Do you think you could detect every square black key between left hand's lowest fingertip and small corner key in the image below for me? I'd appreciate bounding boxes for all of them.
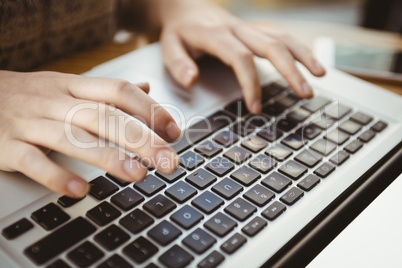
[31,203,70,231]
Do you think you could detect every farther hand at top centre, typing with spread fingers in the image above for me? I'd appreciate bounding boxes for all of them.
[160,0,325,113]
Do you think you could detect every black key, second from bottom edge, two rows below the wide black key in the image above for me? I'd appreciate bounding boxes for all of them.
[123,236,158,263]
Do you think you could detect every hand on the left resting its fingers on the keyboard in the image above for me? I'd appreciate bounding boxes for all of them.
[0,71,180,197]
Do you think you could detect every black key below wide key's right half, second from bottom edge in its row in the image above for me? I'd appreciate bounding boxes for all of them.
[67,241,105,267]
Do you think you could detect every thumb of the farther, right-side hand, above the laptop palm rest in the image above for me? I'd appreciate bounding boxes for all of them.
[160,31,199,88]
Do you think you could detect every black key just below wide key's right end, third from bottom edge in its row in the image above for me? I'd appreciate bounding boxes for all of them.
[94,224,130,250]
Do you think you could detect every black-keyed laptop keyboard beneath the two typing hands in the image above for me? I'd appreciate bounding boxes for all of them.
[2,83,387,267]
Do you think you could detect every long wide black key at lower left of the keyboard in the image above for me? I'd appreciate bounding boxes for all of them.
[24,217,96,265]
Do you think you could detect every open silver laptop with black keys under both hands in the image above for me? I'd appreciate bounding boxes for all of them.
[0,43,402,267]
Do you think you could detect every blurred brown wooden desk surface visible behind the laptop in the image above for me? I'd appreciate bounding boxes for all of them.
[38,20,402,95]
